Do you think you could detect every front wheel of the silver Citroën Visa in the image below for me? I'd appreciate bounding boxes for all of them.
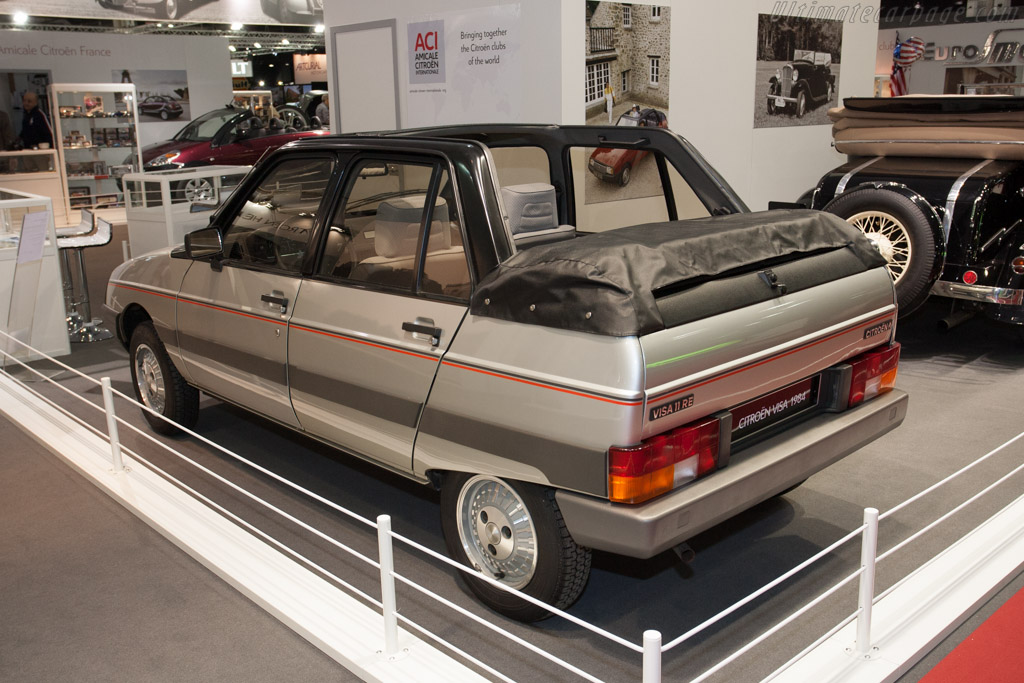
[129,322,199,436]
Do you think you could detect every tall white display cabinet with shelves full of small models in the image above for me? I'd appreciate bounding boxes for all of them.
[50,83,142,221]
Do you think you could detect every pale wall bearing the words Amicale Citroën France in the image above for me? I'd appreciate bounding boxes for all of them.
[0,31,231,144]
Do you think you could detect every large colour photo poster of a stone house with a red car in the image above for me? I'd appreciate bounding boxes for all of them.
[584,2,672,204]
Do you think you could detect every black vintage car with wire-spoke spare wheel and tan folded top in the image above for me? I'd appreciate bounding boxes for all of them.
[811,95,1024,327]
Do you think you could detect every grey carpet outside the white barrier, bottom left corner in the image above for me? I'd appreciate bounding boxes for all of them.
[0,419,356,683]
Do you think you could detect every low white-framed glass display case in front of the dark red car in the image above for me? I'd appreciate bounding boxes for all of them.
[124,166,251,256]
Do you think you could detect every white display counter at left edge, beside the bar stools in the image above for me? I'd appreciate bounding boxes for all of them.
[0,185,71,359]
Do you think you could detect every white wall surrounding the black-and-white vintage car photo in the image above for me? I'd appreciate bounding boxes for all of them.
[671,0,879,211]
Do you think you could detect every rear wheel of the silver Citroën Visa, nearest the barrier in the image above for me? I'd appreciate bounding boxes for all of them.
[441,473,592,622]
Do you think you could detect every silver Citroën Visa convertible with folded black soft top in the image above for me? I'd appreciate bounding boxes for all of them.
[106,125,907,621]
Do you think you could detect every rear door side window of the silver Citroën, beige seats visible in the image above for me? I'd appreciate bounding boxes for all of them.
[318,160,470,299]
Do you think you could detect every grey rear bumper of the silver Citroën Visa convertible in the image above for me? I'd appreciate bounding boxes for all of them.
[556,390,907,558]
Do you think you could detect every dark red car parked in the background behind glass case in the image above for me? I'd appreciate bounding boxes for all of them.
[142,106,328,171]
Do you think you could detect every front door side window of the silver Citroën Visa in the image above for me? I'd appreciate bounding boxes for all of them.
[223,158,334,272]
